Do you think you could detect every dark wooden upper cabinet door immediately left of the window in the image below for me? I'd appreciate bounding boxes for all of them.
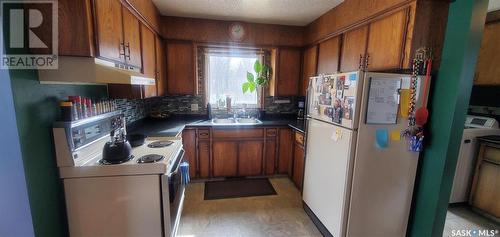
[167,42,196,95]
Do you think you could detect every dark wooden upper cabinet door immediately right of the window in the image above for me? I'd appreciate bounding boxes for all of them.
[274,48,300,96]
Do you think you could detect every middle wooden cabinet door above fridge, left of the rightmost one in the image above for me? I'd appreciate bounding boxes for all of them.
[340,26,368,72]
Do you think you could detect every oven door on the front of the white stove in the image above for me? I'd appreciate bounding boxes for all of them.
[162,149,186,236]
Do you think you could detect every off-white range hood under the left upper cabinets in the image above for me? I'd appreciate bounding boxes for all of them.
[38,56,155,85]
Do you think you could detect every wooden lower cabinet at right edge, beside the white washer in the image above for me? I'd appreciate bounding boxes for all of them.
[470,142,500,218]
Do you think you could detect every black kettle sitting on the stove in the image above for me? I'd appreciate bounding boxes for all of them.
[102,118,133,164]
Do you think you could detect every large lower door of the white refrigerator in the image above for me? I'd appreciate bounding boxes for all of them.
[303,119,356,236]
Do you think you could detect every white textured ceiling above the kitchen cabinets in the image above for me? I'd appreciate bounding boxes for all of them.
[153,0,342,26]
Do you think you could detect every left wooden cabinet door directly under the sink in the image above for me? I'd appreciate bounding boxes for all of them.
[212,141,238,177]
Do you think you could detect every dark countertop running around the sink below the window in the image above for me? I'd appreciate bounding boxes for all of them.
[127,116,305,137]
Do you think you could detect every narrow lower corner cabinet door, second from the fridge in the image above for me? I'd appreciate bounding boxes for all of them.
[278,128,293,175]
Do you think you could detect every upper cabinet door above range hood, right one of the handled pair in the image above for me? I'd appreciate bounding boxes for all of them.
[122,7,142,68]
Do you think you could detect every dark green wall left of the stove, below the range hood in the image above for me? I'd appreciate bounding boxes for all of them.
[10,70,107,237]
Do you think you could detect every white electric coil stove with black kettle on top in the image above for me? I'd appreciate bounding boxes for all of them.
[53,112,189,236]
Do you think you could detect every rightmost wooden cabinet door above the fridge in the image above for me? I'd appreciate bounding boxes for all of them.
[367,10,408,71]
